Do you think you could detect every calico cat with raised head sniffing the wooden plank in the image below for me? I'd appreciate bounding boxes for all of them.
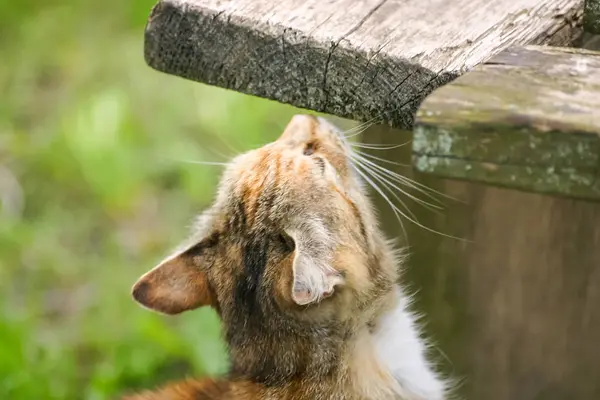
[124,115,447,400]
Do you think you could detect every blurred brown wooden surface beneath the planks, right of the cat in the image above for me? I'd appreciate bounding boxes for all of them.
[362,126,600,400]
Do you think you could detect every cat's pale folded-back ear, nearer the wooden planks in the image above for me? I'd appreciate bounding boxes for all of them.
[287,220,345,305]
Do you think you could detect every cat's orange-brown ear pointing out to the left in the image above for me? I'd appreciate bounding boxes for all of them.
[132,242,214,314]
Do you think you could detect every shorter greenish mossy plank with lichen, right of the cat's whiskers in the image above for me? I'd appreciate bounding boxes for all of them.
[413,46,600,199]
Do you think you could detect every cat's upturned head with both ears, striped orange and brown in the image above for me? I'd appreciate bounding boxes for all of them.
[133,115,394,322]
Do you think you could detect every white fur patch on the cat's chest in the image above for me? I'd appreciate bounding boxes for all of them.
[354,288,445,400]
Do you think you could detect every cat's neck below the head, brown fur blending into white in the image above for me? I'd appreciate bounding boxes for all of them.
[225,287,444,400]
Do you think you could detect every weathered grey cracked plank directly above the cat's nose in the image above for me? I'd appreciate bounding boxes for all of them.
[145,0,583,127]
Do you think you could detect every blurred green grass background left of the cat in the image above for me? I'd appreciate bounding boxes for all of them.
[0,0,338,400]
